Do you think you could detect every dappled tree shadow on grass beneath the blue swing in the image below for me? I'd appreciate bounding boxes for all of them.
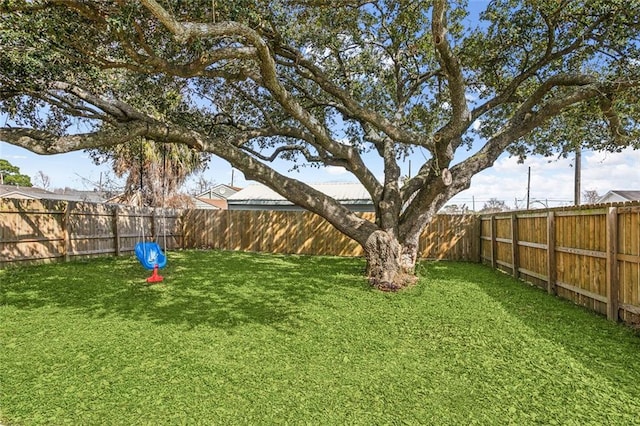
[0,251,366,329]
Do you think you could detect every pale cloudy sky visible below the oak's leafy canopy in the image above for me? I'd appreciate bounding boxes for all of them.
[0,142,640,209]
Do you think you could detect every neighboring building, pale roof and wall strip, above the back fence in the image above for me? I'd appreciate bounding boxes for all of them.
[227,183,374,211]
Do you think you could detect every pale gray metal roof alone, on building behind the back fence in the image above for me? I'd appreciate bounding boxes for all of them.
[227,183,373,205]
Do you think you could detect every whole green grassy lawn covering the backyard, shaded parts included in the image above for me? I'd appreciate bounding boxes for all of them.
[0,251,640,425]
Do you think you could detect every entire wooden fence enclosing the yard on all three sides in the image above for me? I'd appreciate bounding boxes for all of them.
[0,199,640,324]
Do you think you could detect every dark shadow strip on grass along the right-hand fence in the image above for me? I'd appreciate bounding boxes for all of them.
[425,262,640,395]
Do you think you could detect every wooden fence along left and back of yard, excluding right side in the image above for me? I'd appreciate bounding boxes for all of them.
[0,199,480,267]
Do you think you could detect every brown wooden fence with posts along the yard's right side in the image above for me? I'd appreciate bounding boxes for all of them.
[481,203,640,324]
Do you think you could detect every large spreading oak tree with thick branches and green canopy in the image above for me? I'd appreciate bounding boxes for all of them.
[0,0,640,288]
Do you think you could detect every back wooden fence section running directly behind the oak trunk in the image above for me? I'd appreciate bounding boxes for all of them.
[184,210,480,262]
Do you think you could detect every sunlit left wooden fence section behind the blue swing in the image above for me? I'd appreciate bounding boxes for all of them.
[0,198,182,267]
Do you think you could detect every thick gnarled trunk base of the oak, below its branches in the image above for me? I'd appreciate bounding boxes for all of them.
[364,231,418,291]
